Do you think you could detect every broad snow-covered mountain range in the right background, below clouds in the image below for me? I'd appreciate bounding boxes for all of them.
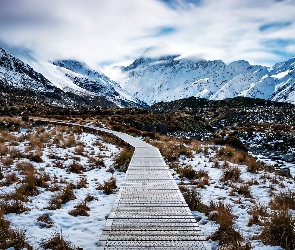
[120,49,295,105]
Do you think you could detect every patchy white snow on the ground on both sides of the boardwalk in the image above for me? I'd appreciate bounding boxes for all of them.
[0,122,295,250]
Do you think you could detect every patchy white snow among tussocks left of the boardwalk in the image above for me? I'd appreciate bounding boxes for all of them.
[0,124,125,249]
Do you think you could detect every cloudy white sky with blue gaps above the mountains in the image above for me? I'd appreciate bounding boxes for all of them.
[0,0,295,77]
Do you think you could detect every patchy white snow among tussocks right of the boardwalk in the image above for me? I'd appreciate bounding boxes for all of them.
[170,145,295,250]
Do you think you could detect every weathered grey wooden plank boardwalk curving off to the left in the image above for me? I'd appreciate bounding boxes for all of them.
[41,121,208,250]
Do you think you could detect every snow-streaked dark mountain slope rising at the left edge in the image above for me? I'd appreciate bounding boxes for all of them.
[0,47,146,107]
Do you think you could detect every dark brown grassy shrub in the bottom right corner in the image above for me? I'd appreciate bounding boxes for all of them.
[260,210,295,250]
